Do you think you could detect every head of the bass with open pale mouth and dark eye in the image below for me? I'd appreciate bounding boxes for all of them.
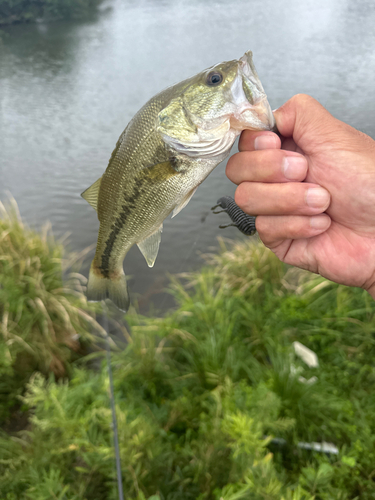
[157,51,275,156]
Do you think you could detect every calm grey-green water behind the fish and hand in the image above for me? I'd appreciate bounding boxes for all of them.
[0,0,375,310]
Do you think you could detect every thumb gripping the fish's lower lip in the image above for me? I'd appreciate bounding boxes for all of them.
[274,94,338,154]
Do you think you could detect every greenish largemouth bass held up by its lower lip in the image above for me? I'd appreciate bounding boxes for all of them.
[81,51,275,312]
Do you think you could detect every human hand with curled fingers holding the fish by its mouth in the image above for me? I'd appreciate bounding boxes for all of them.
[226,94,375,298]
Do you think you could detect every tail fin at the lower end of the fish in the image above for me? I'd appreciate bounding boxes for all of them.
[87,263,130,312]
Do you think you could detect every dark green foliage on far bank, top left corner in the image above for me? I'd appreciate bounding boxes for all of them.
[0,0,101,25]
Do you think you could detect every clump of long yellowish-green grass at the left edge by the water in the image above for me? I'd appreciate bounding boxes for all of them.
[0,200,100,421]
